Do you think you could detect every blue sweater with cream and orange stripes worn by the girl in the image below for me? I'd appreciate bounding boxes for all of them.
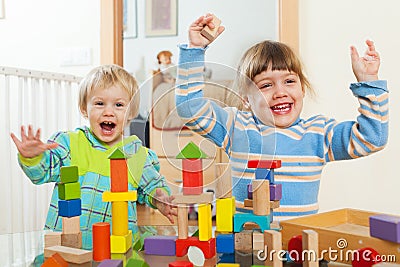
[175,45,388,220]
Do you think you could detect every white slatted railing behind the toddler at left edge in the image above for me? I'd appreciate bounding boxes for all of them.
[0,66,84,266]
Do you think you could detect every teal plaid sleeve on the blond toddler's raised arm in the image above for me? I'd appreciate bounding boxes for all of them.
[18,132,71,184]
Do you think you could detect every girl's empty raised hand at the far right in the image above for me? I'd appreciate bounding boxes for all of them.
[350,40,380,82]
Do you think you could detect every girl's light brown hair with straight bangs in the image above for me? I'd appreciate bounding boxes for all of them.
[235,40,313,109]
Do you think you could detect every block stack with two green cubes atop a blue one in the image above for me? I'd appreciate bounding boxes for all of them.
[58,166,82,248]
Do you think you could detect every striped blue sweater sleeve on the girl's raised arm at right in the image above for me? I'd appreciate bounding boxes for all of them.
[325,80,389,162]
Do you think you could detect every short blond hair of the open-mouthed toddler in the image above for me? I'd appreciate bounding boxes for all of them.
[79,65,140,120]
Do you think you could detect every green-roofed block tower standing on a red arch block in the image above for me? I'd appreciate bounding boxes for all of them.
[173,142,215,259]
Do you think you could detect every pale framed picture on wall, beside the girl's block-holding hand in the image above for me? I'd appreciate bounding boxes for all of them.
[145,0,178,37]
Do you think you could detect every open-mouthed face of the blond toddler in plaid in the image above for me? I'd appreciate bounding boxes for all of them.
[86,85,130,146]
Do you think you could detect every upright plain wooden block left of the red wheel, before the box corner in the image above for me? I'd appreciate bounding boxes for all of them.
[263,230,283,267]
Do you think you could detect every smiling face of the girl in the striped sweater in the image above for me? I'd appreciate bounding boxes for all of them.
[247,68,304,128]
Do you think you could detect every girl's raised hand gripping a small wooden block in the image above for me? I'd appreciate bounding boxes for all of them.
[189,14,225,47]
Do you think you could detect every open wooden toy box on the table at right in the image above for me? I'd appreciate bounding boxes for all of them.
[280,209,400,264]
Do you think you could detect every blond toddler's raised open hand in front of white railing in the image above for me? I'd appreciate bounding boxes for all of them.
[11,125,58,158]
